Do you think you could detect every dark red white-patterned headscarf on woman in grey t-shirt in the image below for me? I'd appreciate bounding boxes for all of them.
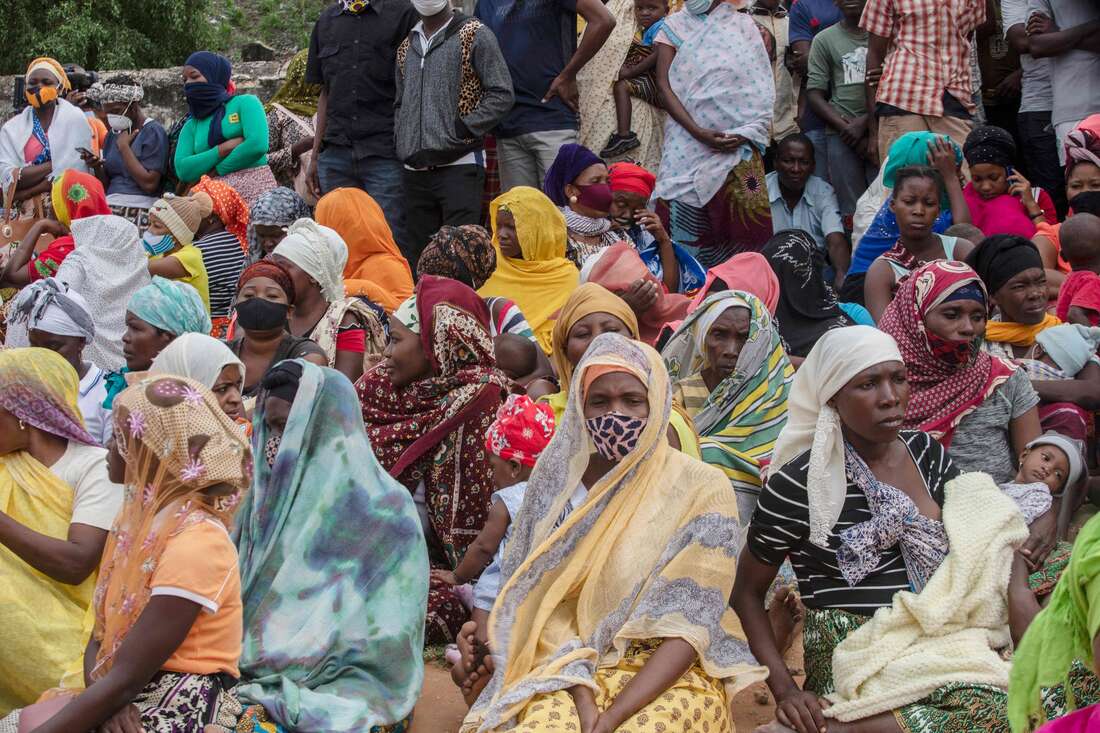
[879,260,1016,448]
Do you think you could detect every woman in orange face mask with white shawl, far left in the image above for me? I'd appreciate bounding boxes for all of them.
[0,56,92,204]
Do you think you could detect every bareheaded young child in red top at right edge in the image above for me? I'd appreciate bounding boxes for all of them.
[1057,214,1100,326]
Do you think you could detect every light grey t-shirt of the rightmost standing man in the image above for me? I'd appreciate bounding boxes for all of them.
[1025,0,1100,124]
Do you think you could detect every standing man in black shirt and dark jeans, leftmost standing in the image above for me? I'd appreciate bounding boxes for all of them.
[306,0,420,244]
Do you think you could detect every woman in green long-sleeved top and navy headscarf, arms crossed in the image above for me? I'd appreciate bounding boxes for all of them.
[174,51,276,205]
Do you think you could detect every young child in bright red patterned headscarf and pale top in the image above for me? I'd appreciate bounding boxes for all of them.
[431,394,554,644]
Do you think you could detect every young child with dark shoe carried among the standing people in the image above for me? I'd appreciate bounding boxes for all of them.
[600,0,669,160]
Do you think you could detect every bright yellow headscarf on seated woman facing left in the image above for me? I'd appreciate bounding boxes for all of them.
[477,186,580,353]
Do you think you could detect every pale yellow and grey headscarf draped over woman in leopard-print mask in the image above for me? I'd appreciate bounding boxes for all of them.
[461,333,767,733]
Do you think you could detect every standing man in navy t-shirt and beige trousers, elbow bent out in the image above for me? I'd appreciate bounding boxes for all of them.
[474,0,615,192]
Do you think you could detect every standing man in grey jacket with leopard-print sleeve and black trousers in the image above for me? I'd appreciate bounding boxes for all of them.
[396,0,513,270]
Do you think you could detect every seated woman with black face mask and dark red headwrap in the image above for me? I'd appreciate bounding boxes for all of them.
[229,260,329,407]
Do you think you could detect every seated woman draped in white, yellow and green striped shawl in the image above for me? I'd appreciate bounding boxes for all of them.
[661,291,794,525]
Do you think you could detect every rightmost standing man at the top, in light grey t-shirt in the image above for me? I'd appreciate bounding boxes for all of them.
[1027,0,1100,165]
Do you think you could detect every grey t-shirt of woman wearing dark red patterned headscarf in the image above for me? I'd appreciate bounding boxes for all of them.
[947,369,1038,484]
